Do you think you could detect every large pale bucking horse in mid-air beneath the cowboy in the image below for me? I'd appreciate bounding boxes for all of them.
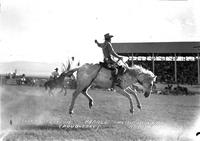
[67,61,156,114]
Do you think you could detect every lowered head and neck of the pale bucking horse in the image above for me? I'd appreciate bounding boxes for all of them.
[128,65,157,97]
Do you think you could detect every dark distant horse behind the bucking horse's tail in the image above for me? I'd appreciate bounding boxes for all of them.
[44,72,67,96]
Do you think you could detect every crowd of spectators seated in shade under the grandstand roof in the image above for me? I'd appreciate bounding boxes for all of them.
[127,60,198,85]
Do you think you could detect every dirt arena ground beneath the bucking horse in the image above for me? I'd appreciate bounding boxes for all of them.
[0,86,200,141]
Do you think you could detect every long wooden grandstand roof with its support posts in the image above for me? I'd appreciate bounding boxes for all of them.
[113,42,200,84]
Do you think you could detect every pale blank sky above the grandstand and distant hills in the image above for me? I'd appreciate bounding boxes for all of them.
[0,0,200,63]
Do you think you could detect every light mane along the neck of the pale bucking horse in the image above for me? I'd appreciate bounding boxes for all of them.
[127,65,155,77]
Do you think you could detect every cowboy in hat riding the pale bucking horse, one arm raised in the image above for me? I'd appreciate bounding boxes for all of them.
[95,33,123,88]
